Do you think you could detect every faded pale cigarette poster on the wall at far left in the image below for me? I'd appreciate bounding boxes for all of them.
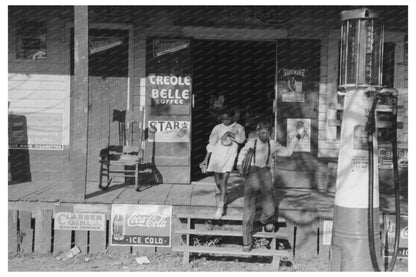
[9,112,64,150]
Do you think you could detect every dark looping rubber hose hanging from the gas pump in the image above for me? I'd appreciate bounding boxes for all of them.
[366,89,400,271]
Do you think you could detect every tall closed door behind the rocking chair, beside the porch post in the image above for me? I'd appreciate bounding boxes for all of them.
[70,28,130,182]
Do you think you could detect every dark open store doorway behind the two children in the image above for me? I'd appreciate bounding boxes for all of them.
[191,40,276,181]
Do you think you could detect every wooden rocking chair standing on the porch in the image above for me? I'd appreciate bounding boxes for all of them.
[98,110,143,191]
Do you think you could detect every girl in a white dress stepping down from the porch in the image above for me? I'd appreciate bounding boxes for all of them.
[200,109,246,219]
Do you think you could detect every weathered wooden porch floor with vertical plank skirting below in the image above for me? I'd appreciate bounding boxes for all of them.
[8,173,407,259]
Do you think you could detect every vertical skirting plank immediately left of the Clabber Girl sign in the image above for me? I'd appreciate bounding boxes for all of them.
[35,209,53,254]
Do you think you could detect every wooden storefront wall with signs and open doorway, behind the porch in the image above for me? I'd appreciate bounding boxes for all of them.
[9,6,408,195]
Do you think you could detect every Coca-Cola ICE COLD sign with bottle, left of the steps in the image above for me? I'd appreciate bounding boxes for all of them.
[110,204,172,247]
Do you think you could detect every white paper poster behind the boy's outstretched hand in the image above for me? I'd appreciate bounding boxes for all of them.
[287,118,311,152]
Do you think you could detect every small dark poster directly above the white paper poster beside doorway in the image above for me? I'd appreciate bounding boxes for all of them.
[278,68,305,102]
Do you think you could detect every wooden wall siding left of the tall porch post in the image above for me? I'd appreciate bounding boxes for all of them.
[8,7,73,181]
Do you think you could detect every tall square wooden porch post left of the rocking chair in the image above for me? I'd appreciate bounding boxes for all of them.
[69,6,88,200]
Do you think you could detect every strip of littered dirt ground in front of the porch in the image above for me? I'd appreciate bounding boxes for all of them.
[8,253,408,272]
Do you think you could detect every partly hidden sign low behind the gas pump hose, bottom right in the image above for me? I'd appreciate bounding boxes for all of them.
[384,215,409,258]
